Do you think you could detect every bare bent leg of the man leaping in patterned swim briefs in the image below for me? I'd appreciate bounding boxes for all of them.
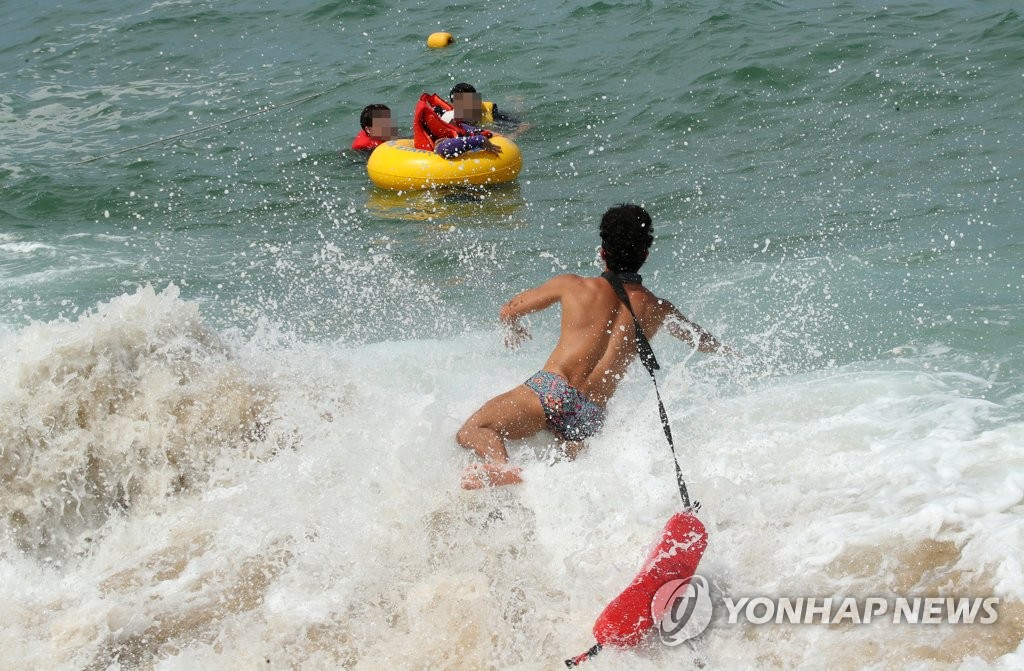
[456,384,547,490]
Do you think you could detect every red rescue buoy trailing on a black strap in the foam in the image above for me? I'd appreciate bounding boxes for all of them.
[565,511,708,667]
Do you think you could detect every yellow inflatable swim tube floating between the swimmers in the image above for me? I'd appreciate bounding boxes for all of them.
[367,135,522,191]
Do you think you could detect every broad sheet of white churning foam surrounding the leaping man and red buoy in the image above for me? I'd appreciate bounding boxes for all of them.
[0,315,1024,670]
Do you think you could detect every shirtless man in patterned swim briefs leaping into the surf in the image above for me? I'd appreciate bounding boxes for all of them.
[456,204,735,490]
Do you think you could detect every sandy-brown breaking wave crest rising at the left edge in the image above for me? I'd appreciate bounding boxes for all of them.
[0,286,276,559]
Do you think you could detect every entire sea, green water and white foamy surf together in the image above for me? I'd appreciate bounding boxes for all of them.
[0,0,1024,669]
